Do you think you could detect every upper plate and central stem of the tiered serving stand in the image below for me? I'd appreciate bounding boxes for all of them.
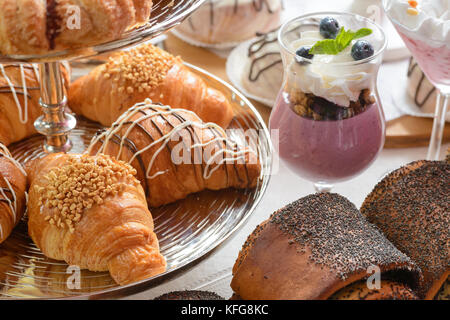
[0,0,205,153]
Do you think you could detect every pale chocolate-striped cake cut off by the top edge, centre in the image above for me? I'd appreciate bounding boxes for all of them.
[175,0,282,45]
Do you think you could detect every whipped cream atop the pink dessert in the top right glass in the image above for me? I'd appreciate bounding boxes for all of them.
[385,0,450,47]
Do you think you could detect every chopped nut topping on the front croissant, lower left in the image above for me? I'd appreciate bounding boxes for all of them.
[34,155,139,232]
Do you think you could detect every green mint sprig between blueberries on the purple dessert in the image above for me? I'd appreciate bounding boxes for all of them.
[309,28,372,55]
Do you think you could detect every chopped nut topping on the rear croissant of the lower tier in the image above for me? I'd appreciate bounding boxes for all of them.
[103,44,179,94]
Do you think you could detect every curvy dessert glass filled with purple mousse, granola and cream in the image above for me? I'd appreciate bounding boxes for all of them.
[270,12,386,192]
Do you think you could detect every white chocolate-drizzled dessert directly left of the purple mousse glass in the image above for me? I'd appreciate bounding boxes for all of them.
[241,30,284,101]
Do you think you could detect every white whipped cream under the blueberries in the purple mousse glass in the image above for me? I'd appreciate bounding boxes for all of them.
[288,31,378,107]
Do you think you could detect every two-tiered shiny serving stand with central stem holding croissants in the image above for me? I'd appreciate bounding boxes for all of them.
[0,0,272,299]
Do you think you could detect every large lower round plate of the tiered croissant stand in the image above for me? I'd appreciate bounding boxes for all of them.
[0,65,272,299]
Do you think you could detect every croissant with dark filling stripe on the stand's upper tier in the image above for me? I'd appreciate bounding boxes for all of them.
[0,0,152,55]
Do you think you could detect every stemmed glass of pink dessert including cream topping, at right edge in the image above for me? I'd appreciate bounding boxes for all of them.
[383,0,450,160]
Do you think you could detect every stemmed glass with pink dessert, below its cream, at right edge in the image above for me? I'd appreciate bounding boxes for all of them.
[383,0,450,160]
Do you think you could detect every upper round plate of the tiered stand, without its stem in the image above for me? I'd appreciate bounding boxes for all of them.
[0,0,205,62]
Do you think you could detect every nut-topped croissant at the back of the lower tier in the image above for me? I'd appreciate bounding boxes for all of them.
[69,44,233,128]
